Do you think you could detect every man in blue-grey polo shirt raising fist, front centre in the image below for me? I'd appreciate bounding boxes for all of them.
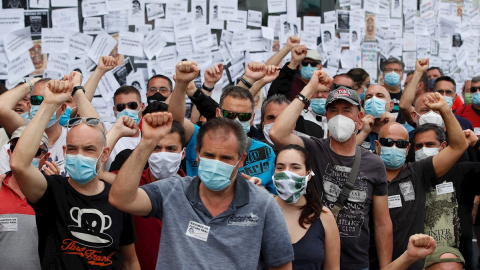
[109,112,294,269]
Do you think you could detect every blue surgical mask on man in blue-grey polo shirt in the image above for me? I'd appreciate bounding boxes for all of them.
[198,157,240,191]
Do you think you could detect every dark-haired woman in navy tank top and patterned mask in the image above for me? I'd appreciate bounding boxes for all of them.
[273,144,340,269]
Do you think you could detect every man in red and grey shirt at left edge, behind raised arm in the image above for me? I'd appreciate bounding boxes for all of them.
[0,126,49,269]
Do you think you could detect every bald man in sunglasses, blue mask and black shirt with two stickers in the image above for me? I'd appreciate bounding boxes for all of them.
[375,93,468,269]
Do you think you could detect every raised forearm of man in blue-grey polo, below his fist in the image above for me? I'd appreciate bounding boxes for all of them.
[109,139,156,206]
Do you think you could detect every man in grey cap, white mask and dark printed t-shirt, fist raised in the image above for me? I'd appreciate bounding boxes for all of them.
[270,70,392,269]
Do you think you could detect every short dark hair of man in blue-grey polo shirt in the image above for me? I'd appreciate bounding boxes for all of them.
[197,117,248,157]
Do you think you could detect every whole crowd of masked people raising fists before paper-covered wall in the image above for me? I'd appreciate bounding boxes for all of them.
[0,36,480,270]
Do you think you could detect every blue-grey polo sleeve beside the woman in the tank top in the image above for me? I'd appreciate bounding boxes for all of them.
[260,196,295,267]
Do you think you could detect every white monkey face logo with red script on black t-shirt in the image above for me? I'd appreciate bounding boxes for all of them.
[61,207,114,266]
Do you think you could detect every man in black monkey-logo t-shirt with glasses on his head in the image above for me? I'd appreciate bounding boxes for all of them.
[11,72,140,269]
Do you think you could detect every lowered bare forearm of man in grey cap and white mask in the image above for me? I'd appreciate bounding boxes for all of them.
[375,217,393,269]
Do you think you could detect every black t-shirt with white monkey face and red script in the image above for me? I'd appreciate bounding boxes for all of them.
[30,175,136,269]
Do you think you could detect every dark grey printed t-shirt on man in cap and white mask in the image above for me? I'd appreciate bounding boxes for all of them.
[300,137,387,269]
